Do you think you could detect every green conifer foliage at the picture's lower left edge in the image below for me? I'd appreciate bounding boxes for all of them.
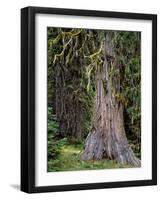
[48,107,67,160]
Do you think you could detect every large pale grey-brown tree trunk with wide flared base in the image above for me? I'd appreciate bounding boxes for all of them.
[81,33,140,166]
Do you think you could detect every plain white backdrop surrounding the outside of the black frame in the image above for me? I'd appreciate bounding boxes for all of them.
[0,0,161,200]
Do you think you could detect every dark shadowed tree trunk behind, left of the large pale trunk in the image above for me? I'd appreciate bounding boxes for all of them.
[54,63,82,140]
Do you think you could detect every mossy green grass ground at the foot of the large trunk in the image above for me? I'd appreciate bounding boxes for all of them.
[48,144,131,172]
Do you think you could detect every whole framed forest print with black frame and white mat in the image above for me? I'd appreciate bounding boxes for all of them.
[21,7,157,193]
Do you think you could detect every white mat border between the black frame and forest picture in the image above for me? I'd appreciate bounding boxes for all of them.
[35,14,152,186]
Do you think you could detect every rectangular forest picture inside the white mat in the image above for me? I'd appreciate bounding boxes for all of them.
[47,27,141,172]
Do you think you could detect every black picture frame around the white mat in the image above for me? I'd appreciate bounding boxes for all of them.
[21,7,157,193]
